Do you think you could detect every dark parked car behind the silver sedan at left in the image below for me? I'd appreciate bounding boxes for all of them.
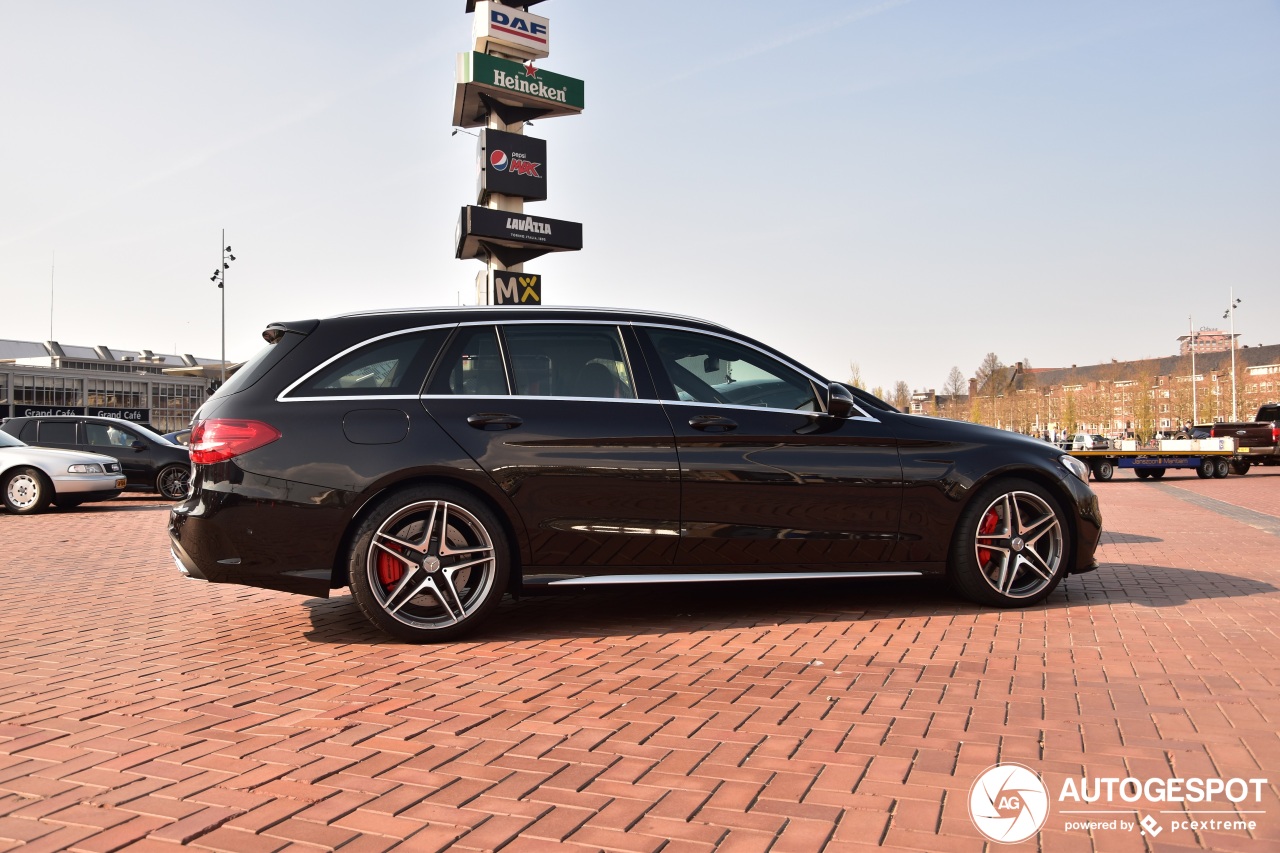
[0,415,191,501]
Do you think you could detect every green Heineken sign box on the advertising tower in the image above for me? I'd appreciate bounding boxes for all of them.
[453,53,584,127]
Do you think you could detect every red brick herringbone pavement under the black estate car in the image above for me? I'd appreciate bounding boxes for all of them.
[0,470,1280,853]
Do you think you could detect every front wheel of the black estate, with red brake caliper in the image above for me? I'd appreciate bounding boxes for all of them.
[947,479,1070,607]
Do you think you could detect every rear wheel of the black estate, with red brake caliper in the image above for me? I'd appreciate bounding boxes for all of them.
[347,485,511,643]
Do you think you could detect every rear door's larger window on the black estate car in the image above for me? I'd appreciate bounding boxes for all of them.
[502,324,636,400]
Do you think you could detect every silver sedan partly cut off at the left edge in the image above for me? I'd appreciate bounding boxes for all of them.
[0,432,125,515]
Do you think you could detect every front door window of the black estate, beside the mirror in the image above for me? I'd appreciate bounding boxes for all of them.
[648,329,818,411]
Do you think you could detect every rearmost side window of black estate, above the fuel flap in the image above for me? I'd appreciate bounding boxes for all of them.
[289,329,448,397]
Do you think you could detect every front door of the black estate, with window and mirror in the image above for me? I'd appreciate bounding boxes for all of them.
[636,320,902,569]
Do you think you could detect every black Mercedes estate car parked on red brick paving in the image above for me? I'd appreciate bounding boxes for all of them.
[169,307,1102,642]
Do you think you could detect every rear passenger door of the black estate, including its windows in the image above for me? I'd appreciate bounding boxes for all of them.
[422,323,680,569]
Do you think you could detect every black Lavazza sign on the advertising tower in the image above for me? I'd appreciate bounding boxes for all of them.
[454,205,582,266]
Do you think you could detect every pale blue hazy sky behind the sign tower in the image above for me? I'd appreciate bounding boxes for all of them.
[0,0,1280,389]
